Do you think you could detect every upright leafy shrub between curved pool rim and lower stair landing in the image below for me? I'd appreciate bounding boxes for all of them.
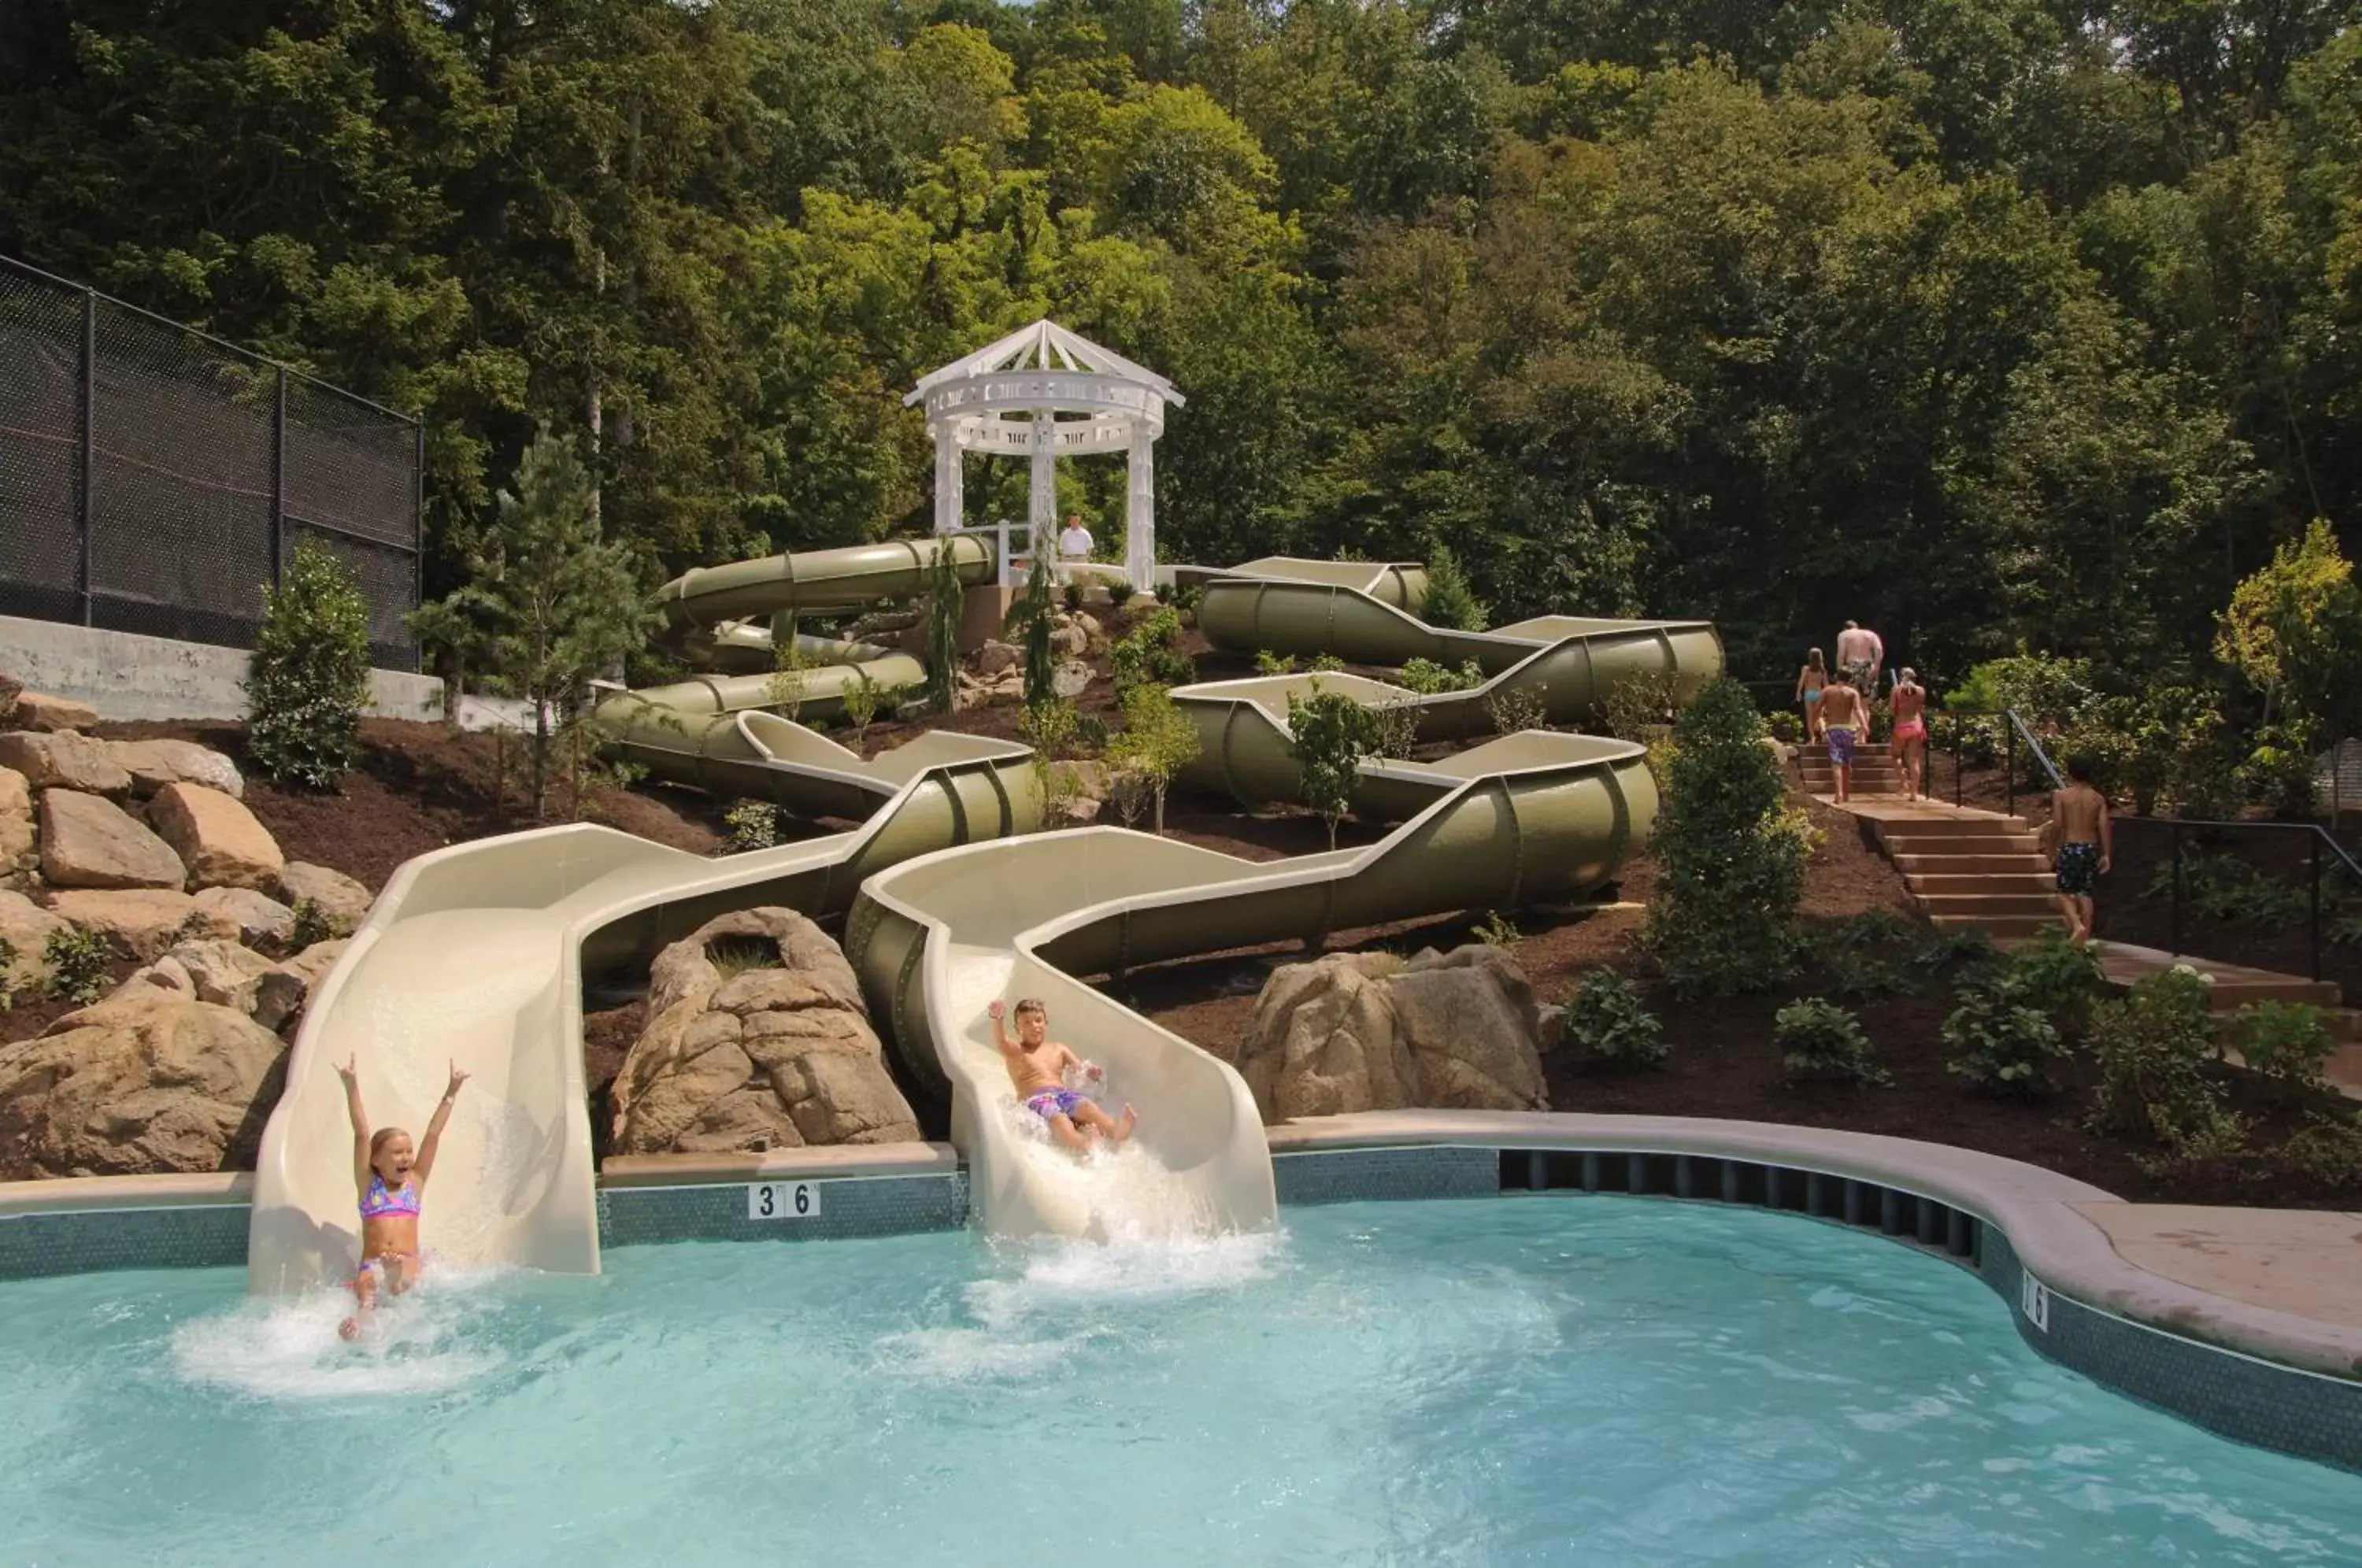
[2086,963,2223,1148]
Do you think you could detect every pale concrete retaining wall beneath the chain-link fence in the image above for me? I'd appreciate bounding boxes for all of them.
[0,616,442,720]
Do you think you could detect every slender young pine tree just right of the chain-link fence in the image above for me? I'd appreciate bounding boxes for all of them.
[413,430,657,819]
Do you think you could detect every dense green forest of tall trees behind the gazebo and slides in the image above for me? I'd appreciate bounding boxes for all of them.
[13,0,2362,675]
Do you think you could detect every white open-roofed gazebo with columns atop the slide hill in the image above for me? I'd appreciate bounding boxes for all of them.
[902,321,1183,593]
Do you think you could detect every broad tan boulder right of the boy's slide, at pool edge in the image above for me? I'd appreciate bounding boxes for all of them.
[1238,947,1549,1122]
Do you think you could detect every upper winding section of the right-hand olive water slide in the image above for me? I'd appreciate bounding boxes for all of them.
[1174,555,1722,819]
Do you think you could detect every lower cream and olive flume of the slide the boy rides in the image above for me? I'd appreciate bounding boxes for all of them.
[846,732,1656,1235]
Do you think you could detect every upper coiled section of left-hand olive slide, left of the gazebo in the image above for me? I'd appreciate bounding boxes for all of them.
[593,534,1030,822]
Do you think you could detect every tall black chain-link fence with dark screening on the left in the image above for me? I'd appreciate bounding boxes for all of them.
[0,257,423,671]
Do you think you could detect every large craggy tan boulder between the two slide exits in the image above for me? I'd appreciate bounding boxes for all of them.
[612,909,919,1155]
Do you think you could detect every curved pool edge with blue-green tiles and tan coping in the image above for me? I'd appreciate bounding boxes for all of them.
[0,1112,2362,1471]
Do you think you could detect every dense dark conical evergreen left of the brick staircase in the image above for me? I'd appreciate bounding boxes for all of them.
[1644,680,1809,997]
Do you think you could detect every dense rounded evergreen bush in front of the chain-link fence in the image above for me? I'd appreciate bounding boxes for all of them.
[246,538,368,789]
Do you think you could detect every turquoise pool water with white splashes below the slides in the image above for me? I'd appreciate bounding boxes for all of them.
[0,1197,2362,1568]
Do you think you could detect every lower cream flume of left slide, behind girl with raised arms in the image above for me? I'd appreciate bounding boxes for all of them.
[246,756,1042,1292]
